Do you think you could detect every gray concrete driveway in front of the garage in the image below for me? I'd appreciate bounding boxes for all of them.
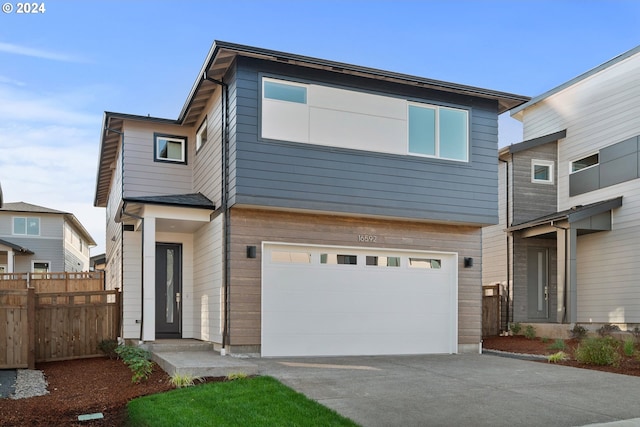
[251,354,640,427]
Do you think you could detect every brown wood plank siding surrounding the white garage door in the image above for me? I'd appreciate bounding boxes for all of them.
[229,208,482,347]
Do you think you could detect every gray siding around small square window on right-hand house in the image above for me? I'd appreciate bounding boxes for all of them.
[512,141,558,224]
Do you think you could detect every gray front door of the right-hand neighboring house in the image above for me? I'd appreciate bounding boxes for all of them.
[527,248,549,320]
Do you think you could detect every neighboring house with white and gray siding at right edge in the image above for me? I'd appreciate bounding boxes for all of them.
[483,47,640,331]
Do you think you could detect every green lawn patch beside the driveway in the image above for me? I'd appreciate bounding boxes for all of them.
[128,377,357,427]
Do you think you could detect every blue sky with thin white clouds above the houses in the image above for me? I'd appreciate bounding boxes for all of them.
[0,0,640,254]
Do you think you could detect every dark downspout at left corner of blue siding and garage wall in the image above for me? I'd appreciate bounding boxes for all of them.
[202,72,231,353]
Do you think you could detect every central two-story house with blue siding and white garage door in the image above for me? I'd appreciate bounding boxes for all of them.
[95,42,529,356]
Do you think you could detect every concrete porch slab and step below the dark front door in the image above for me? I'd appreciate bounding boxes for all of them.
[151,350,258,377]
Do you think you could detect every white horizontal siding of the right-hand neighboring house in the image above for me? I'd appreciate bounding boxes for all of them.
[523,54,640,323]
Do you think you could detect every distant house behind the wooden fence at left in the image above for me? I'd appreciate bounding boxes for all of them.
[0,202,96,273]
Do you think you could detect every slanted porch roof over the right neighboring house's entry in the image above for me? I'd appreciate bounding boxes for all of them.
[506,196,622,237]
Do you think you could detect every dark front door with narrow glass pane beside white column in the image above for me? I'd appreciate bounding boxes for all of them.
[156,243,182,338]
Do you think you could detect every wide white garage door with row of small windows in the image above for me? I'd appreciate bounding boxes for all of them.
[262,243,458,356]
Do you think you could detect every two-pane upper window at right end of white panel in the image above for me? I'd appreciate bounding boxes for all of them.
[409,103,469,162]
